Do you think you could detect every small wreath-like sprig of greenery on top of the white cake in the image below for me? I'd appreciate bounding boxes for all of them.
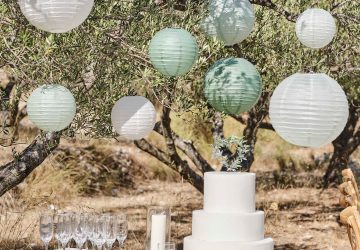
[213,135,250,172]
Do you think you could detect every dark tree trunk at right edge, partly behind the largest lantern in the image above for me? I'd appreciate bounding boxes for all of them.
[323,104,360,187]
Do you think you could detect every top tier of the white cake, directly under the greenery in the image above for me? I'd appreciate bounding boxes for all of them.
[204,172,256,213]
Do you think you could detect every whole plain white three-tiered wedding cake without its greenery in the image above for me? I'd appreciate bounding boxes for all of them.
[184,172,274,250]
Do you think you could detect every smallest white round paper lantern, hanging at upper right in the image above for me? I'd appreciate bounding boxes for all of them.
[296,8,336,49]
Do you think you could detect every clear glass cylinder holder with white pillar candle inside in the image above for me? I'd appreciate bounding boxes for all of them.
[146,207,171,250]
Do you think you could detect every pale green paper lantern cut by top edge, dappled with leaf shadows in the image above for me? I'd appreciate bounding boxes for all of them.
[200,0,255,45]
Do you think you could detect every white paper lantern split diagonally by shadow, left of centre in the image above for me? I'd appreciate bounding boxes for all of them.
[111,96,156,140]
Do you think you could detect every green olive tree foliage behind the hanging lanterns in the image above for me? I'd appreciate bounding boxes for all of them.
[0,0,360,137]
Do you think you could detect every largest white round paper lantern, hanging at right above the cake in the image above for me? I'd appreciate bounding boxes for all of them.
[269,73,349,147]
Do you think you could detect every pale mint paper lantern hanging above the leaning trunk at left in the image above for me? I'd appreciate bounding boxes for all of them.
[27,85,76,131]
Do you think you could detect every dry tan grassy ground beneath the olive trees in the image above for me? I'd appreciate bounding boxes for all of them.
[0,113,360,250]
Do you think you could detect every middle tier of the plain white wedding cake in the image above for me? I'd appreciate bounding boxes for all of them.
[192,210,264,241]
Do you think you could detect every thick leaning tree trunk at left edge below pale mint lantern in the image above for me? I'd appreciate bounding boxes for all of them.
[0,132,60,197]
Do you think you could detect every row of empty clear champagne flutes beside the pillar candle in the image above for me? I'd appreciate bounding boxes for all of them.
[40,212,128,250]
